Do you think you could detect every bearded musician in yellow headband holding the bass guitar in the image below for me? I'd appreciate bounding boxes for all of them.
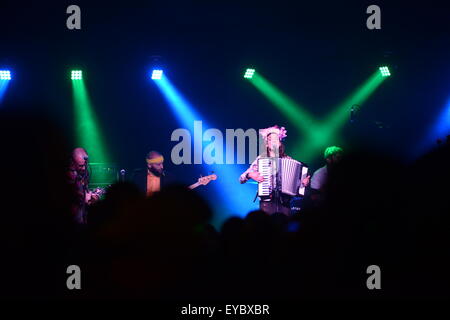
[132,151,172,196]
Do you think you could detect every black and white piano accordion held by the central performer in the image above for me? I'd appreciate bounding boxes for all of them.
[258,157,308,197]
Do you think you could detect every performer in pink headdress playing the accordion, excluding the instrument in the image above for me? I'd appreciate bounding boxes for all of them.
[239,125,310,215]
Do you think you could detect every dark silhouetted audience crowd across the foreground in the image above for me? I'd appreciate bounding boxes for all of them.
[0,107,450,301]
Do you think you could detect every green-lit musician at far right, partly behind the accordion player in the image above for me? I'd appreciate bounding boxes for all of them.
[311,146,343,203]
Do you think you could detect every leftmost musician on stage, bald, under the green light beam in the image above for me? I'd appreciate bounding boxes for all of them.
[68,148,99,224]
